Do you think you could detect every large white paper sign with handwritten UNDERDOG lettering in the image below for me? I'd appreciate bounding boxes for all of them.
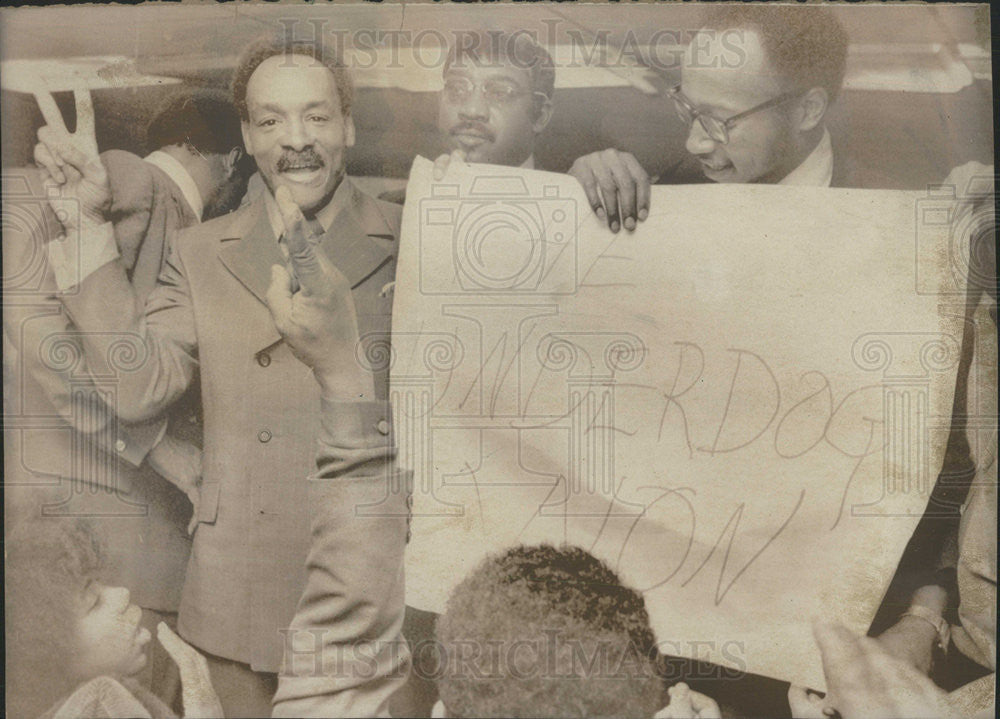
[386,158,964,688]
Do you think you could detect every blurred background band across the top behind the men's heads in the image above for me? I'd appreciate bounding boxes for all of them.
[0,3,993,189]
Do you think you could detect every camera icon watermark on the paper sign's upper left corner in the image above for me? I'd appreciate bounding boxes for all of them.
[419,176,578,296]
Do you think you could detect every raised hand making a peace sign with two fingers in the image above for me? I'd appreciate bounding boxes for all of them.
[35,90,111,232]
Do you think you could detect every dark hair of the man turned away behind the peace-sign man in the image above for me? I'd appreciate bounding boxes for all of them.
[146,88,243,155]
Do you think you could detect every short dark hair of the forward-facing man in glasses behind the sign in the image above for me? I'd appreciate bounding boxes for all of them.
[443,30,556,113]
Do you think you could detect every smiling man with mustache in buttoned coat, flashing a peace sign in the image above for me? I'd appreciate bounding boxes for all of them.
[33,40,408,717]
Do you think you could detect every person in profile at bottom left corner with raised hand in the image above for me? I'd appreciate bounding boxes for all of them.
[4,519,222,719]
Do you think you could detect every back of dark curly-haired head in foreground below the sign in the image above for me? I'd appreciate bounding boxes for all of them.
[437,545,662,717]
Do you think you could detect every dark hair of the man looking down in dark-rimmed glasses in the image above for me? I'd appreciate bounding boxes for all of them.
[702,3,848,104]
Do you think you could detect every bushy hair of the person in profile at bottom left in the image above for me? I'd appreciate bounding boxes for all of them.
[4,518,104,717]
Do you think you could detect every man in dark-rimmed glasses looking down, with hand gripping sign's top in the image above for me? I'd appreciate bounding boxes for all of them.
[570,6,854,232]
